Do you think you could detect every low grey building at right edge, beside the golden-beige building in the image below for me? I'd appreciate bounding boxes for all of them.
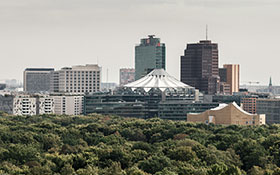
[256,99,280,124]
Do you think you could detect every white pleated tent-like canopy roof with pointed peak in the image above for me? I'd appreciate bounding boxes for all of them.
[124,69,194,92]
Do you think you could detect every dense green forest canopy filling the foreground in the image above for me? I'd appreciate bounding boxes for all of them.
[0,114,280,175]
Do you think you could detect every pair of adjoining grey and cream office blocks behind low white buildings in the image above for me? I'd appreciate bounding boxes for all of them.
[23,64,101,94]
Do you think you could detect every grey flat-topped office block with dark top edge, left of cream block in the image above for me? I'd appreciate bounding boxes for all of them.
[23,68,54,93]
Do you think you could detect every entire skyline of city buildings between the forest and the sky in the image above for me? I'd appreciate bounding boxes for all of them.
[0,35,280,125]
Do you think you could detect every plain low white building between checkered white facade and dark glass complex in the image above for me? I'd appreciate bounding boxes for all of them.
[52,95,84,115]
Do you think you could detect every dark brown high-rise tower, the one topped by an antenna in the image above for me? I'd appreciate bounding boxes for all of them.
[181,40,220,94]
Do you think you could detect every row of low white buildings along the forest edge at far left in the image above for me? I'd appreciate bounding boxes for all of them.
[0,93,84,115]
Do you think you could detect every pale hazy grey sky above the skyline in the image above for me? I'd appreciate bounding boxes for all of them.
[0,0,280,84]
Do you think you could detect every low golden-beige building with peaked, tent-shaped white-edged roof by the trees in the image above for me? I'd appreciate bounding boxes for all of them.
[187,102,265,125]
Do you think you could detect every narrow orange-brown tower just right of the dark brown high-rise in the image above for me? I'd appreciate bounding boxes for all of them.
[224,64,239,94]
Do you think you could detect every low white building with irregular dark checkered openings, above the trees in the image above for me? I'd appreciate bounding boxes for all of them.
[13,95,54,115]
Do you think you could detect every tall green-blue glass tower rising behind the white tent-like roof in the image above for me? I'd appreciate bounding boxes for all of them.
[135,35,165,80]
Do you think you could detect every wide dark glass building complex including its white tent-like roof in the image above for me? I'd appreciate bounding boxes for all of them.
[84,69,205,120]
